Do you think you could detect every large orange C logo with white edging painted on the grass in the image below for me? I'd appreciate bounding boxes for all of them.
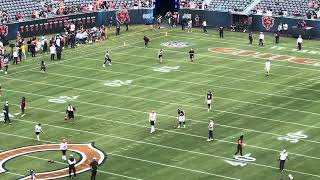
[0,144,105,180]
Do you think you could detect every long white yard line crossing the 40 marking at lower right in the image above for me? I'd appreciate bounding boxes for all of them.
[2,118,320,177]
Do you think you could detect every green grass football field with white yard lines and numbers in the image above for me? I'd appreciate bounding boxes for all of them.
[0,26,320,180]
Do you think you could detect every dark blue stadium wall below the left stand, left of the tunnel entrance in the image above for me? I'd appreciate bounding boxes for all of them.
[1,9,153,40]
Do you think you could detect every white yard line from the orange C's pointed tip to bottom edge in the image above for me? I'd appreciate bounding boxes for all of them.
[110,153,240,180]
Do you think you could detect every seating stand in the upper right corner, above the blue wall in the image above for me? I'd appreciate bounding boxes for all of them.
[253,0,319,19]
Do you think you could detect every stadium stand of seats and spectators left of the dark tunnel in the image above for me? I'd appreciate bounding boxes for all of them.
[0,0,152,23]
